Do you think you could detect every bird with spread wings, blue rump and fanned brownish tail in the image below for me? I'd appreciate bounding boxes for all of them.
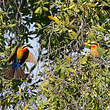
[3,45,37,79]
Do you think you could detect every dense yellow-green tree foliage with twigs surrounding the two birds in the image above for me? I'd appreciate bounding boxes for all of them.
[0,0,110,110]
